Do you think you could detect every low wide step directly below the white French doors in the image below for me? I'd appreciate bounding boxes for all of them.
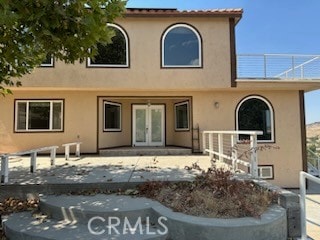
[99,147,192,157]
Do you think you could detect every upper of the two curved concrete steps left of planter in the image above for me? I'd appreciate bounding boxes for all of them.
[40,194,160,224]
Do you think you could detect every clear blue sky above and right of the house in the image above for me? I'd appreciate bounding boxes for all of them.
[127,0,320,123]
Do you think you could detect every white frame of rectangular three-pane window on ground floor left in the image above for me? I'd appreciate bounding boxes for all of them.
[14,100,64,132]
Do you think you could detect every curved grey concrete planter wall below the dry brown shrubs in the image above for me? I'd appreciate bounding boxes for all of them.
[153,205,287,240]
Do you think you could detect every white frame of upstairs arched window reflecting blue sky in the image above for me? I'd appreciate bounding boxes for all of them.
[161,23,202,68]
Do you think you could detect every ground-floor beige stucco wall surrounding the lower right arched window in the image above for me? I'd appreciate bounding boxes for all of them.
[193,91,302,187]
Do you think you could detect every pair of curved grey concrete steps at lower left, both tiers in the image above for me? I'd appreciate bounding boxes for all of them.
[3,194,167,240]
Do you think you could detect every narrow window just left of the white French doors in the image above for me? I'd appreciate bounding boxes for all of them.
[103,101,121,132]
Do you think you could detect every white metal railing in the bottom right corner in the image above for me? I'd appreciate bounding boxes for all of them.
[300,171,320,240]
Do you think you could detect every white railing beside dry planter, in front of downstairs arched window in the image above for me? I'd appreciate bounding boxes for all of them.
[202,131,263,178]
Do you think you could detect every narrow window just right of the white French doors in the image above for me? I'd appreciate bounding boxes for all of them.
[174,102,189,131]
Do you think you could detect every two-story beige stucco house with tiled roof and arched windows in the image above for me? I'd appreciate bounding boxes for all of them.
[0,9,320,187]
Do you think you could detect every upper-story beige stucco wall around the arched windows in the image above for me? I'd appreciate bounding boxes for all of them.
[17,17,231,90]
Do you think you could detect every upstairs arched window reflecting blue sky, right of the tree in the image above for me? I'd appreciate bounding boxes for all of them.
[162,24,202,67]
